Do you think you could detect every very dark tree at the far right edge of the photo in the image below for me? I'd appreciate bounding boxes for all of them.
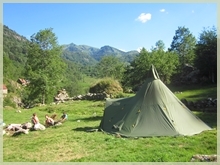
[195,27,217,82]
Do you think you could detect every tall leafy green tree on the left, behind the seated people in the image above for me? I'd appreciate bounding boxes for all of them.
[26,28,66,104]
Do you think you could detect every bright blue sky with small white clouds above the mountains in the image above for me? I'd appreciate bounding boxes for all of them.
[3,3,217,51]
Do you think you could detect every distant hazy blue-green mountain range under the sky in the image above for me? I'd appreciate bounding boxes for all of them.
[63,43,139,65]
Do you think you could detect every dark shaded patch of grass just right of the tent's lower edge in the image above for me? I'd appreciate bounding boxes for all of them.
[196,112,217,128]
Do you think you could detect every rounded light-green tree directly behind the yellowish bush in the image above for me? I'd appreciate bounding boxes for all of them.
[96,55,125,81]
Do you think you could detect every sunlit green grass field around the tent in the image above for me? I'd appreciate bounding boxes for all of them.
[3,86,217,162]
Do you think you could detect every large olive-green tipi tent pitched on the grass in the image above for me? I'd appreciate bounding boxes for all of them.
[100,65,211,137]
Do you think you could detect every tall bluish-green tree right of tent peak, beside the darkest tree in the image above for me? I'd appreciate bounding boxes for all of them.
[169,27,196,67]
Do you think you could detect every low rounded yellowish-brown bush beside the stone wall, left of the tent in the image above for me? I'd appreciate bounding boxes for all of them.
[89,78,123,95]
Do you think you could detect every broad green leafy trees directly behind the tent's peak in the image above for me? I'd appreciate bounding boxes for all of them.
[123,41,179,88]
